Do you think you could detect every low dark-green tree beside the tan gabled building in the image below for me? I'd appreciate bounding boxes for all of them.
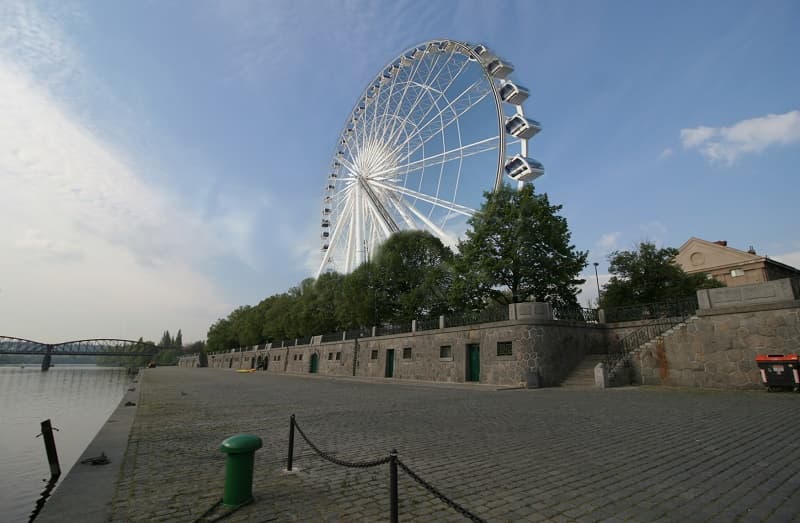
[600,242,724,307]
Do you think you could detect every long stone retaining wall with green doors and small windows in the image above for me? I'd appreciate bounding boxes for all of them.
[179,315,638,387]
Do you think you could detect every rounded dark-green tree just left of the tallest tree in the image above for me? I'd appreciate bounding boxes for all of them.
[370,231,453,323]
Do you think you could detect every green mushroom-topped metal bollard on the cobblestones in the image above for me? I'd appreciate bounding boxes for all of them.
[219,434,262,507]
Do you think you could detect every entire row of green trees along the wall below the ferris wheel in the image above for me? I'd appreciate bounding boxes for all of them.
[206,186,586,352]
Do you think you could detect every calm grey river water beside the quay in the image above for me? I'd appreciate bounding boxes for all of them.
[0,365,131,522]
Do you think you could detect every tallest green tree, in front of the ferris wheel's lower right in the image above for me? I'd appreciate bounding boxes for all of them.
[451,184,588,308]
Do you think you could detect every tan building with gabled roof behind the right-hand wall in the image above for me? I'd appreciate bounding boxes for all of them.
[675,237,800,287]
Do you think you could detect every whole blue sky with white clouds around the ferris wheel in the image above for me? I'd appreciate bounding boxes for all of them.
[0,0,800,341]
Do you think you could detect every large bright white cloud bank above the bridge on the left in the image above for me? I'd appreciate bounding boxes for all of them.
[0,54,230,341]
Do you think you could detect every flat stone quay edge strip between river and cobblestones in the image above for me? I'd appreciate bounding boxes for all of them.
[36,369,144,523]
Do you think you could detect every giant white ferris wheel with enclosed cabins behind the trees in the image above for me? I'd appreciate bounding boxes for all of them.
[317,40,544,276]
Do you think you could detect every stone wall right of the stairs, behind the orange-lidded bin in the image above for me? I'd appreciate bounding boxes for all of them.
[632,302,800,389]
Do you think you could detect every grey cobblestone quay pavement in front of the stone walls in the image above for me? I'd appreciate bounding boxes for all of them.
[112,368,800,522]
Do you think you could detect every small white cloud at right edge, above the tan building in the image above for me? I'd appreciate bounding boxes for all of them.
[681,110,800,165]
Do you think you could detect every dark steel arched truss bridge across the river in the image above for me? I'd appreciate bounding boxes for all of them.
[0,336,161,371]
